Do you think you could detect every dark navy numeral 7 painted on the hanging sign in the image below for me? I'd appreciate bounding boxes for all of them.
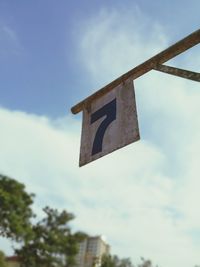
[90,98,116,156]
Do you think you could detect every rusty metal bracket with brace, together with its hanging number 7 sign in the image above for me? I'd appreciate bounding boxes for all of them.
[71,29,200,166]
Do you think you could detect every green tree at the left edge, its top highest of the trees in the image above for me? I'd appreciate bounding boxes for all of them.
[0,175,34,241]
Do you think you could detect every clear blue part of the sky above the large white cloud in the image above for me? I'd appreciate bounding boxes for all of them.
[0,0,199,117]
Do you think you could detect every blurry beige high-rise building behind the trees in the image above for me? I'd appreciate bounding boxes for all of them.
[76,236,110,267]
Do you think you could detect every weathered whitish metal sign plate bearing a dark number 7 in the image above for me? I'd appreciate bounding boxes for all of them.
[79,80,140,166]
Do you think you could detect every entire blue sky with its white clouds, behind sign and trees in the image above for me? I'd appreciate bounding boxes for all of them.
[0,0,200,267]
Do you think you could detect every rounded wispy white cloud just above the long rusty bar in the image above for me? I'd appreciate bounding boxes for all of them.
[77,7,167,89]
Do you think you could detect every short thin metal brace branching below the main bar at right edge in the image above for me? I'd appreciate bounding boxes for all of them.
[154,64,200,82]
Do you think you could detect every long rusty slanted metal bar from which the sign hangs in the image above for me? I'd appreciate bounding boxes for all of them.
[71,29,200,114]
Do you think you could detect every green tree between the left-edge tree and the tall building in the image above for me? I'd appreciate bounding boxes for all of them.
[16,207,86,267]
